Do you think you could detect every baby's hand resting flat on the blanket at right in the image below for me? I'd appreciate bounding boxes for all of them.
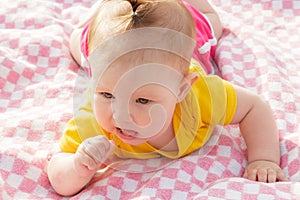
[244,160,288,183]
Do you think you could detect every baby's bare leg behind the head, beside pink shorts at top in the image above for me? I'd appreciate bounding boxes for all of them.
[185,0,223,39]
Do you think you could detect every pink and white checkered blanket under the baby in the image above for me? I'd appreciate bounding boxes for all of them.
[0,0,300,199]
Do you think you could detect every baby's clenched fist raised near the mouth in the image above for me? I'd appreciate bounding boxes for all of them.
[74,136,114,176]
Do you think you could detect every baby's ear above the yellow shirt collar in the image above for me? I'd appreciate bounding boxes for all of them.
[177,72,199,102]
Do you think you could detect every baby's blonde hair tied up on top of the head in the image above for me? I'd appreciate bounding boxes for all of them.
[88,0,196,71]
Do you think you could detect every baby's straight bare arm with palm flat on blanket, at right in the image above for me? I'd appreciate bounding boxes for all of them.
[231,86,287,182]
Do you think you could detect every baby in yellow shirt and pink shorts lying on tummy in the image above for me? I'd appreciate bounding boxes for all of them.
[48,0,287,195]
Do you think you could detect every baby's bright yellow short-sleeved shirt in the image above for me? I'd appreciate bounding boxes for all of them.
[60,60,237,159]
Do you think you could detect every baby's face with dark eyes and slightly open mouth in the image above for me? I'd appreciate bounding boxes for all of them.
[94,59,184,145]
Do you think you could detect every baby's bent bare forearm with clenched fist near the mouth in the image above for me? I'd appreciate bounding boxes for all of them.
[47,136,114,196]
